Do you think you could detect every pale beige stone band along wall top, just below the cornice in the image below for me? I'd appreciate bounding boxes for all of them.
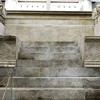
[6,18,94,26]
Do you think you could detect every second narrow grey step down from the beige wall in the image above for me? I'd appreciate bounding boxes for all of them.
[20,46,79,53]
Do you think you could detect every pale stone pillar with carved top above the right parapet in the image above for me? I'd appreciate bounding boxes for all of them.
[92,5,100,36]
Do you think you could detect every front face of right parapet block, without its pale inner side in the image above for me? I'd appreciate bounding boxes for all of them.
[84,36,100,67]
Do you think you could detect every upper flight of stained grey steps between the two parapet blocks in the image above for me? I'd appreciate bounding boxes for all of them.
[17,42,82,67]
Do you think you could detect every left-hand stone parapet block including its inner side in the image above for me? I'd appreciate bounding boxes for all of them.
[0,36,18,67]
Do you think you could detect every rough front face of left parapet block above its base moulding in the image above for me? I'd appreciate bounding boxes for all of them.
[0,36,16,61]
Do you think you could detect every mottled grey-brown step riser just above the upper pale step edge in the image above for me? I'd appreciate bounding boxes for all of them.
[14,67,100,77]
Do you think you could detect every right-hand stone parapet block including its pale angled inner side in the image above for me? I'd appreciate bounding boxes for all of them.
[78,36,100,67]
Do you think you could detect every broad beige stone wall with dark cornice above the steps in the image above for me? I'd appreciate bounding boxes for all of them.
[5,11,94,41]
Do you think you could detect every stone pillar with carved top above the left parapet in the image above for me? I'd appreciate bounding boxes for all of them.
[0,0,5,35]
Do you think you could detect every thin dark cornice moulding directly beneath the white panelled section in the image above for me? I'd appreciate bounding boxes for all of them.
[7,10,92,16]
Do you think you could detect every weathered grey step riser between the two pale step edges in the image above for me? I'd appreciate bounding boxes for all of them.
[12,77,100,89]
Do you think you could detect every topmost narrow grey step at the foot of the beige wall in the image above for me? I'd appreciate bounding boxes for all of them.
[21,41,78,48]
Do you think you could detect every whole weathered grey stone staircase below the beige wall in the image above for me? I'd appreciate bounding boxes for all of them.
[0,42,100,100]
